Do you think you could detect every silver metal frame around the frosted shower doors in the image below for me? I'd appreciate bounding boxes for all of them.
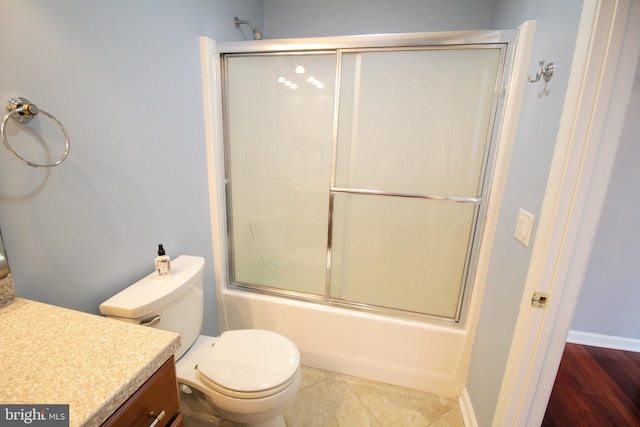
[217,30,517,328]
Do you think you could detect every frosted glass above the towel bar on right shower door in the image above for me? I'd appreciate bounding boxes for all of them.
[335,48,501,197]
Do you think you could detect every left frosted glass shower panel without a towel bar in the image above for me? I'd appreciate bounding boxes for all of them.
[225,55,336,295]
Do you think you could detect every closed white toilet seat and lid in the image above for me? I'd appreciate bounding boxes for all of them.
[196,329,300,399]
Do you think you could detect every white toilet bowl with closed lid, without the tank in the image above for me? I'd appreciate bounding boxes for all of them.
[176,329,300,427]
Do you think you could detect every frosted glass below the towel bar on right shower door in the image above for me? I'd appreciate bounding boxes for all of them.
[331,193,475,319]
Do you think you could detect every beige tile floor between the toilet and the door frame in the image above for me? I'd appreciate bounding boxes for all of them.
[284,367,464,427]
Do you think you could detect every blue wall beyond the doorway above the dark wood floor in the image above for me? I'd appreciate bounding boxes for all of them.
[571,59,640,340]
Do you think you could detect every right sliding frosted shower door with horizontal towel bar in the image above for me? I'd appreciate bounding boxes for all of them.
[331,48,500,318]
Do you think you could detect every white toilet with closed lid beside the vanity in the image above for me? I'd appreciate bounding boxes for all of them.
[100,255,300,427]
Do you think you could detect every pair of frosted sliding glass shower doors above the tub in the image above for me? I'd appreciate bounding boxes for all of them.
[223,40,505,321]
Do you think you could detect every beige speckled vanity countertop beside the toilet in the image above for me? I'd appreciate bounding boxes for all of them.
[0,298,179,427]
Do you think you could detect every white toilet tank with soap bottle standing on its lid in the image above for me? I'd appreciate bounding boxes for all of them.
[100,255,204,360]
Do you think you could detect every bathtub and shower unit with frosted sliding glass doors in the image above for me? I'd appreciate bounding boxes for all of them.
[202,31,518,395]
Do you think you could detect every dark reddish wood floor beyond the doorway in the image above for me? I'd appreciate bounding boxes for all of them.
[542,343,640,427]
